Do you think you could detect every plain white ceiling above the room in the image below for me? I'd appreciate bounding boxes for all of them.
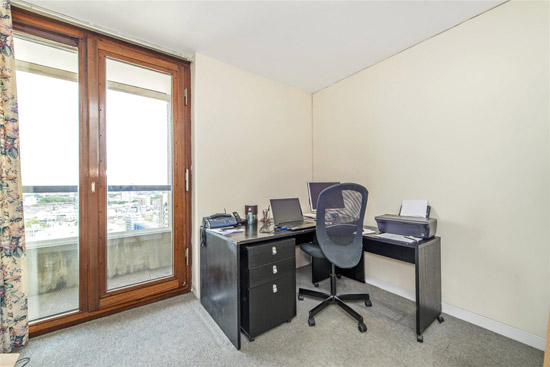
[20,0,503,92]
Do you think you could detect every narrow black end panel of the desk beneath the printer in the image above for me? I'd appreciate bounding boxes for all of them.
[415,238,443,342]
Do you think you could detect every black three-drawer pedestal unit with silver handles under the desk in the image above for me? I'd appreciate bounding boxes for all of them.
[241,239,296,341]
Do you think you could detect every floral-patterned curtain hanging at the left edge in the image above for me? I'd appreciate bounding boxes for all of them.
[0,0,29,353]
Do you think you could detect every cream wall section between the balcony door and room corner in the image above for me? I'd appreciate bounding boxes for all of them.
[192,54,312,295]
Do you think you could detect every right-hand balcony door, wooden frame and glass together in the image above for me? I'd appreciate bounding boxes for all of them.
[97,44,186,308]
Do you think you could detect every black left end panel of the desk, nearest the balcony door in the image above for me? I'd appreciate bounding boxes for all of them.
[201,233,241,349]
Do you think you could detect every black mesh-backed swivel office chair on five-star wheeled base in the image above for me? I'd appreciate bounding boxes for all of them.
[298,183,372,333]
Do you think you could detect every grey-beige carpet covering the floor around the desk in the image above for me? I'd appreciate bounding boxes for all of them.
[21,267,543,367]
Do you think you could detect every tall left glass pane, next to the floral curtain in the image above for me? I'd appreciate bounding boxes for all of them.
[14,36,79,321]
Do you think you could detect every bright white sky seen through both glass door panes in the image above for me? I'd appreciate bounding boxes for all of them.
[17,71,171,186]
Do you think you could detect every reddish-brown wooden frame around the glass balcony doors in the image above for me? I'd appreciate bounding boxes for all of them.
[12,7,192,337]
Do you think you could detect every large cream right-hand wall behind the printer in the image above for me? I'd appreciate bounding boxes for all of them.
[313,1,550,338]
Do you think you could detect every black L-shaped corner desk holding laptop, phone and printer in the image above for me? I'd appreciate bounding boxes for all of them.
[200,224,443,349]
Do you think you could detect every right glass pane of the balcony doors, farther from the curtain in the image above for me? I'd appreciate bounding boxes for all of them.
[106,58,173,290]
